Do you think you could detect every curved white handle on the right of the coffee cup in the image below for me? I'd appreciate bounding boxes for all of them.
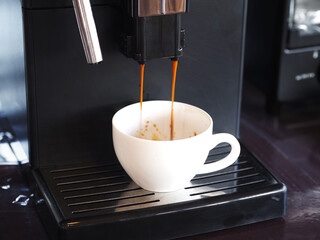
[197,133,241,174]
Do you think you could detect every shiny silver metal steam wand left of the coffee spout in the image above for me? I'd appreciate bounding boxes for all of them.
[72,0,102,63]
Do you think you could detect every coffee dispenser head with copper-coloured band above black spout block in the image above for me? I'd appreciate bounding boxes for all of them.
[121,0,189,64]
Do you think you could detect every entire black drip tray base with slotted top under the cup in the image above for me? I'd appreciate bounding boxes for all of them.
[34,143,286,239]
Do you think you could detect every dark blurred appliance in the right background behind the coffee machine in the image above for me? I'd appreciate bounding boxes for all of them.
[244,0,320,113]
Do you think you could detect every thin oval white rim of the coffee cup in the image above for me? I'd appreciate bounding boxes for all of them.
[112,100,213,144]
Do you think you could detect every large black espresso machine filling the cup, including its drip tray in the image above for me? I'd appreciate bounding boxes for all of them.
[2,0,286,239]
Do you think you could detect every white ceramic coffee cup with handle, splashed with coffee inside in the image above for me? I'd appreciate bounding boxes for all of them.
[112,101,240,192]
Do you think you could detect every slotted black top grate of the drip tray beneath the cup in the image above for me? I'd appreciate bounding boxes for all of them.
[40,142,279,220]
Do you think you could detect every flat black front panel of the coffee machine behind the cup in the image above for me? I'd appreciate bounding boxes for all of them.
[23,0,246,168]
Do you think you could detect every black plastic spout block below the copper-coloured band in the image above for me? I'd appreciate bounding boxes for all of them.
[121,14,184,64]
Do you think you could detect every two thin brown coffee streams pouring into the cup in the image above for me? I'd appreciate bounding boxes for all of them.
[140,60,178,140]
